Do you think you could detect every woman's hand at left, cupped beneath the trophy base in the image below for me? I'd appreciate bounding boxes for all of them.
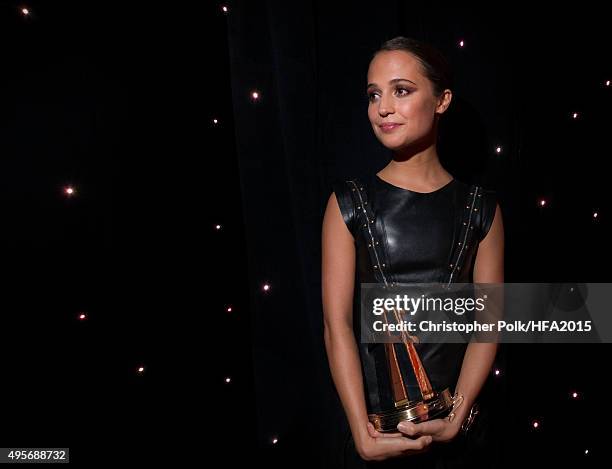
[355,422,432,461]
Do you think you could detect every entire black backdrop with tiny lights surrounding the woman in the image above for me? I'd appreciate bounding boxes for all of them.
[0,1,612,467]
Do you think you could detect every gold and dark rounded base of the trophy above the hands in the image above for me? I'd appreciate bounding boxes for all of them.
[368,388,453,433]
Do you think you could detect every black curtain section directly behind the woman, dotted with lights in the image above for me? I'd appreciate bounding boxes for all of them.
[227,1,610,467]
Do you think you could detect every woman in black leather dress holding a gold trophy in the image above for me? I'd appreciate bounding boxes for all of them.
[322,37,504,467]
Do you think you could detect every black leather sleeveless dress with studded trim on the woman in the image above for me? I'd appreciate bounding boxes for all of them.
[333,174,497,467]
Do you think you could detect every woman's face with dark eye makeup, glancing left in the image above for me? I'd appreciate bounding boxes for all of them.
[367,51,451,150]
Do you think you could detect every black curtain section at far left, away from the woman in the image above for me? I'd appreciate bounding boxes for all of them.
[0,0,255,467]
